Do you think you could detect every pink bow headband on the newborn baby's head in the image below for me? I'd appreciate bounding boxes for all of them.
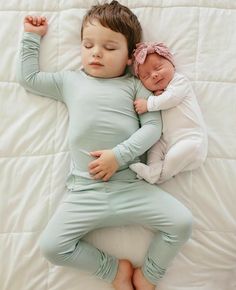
[133,42,175,76]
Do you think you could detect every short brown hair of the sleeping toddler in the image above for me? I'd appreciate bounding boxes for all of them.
[81,0,142,58]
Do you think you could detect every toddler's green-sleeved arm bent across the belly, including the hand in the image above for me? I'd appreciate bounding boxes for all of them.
[89,82,162,181]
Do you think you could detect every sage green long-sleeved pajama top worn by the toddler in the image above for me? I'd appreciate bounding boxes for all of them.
[18,32,162,190]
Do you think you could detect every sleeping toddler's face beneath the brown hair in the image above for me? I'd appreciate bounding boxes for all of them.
[81,20,131,78]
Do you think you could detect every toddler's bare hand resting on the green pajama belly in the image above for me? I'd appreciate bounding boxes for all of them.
[89,150,119,181]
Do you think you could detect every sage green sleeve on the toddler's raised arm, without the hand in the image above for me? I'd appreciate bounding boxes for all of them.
[17,32,63,101]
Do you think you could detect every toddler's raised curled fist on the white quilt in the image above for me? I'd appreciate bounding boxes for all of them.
[24,15,48,36]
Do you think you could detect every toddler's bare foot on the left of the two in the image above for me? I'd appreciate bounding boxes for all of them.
[112,260,134,290]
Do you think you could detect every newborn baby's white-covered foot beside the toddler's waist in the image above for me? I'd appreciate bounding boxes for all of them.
[129,162,161,184]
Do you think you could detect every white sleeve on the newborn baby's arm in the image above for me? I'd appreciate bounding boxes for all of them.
[147,74,189,112]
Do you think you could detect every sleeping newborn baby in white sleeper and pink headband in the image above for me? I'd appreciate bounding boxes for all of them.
[130,42,208,184]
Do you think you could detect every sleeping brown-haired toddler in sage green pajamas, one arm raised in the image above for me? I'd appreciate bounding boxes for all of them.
[18,1,192,290]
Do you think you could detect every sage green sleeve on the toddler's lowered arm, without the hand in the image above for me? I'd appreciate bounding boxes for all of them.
[112,80,162,166]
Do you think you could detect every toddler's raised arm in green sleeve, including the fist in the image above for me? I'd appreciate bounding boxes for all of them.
[17,16,63,100]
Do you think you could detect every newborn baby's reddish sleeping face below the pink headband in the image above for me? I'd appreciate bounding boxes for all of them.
[138,53,175,91]
